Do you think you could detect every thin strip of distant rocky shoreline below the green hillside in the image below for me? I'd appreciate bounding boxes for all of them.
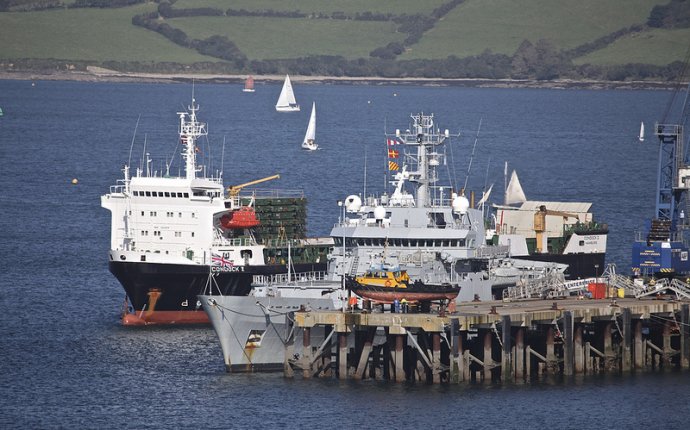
[0,67,675,90]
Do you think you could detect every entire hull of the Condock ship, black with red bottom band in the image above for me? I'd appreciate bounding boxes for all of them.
[109,261,326,325]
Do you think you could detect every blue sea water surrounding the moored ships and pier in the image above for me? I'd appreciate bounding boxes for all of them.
[0,81,690,428]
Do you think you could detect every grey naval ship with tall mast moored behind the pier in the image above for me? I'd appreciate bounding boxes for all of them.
[199,113,566,372]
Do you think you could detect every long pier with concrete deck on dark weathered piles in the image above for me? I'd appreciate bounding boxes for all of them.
[285,299,690,384]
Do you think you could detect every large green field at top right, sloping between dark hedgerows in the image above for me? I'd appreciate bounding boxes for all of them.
[401,0,667,59]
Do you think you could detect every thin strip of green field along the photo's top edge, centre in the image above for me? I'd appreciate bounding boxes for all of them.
[173,0,447,15]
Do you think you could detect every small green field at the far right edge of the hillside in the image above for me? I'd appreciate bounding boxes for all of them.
[575,28,690,66]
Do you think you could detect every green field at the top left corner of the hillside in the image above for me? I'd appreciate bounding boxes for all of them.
[0,4,215,64]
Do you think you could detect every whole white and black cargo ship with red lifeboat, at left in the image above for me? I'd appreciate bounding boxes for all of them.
[101,100,332,324]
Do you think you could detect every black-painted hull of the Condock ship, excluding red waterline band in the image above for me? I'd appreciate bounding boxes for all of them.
[109,261,326,312]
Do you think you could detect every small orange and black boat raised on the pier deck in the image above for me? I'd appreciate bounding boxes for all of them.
[345,267,460,303]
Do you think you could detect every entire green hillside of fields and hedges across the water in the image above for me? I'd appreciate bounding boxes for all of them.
[0,0,690,80]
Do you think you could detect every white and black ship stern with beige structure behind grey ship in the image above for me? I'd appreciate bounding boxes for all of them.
[487,168,608,280]
